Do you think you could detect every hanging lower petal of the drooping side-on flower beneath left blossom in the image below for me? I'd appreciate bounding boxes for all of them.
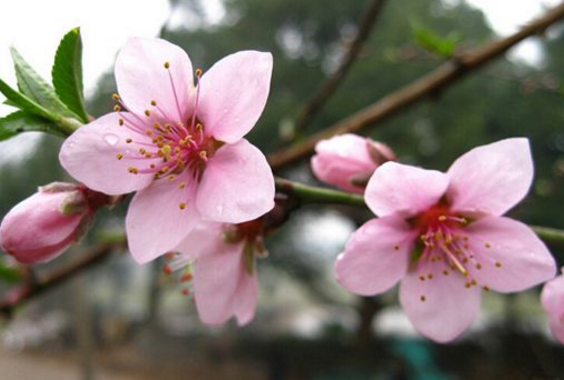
[194,241,258,325]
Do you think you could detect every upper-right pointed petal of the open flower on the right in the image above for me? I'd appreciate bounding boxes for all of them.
[447,138,533,215]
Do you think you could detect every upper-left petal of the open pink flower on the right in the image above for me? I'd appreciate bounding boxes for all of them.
[364,162,448,217]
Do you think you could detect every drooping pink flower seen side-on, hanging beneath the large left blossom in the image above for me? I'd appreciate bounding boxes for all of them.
[166,219,266,325]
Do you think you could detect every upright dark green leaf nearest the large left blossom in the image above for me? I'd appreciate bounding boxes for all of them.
[51,28,88,123]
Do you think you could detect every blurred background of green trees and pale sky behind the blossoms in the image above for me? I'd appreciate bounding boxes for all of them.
[0,0,564,380]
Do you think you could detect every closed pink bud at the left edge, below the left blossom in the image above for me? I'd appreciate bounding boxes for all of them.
[0,183,93,264]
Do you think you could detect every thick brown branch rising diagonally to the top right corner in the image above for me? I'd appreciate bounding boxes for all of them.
[268,3,564,170]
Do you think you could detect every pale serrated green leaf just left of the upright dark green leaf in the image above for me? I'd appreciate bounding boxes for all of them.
[10,47,77,118]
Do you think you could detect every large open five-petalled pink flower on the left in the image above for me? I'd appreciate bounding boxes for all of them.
[59,38,274,263]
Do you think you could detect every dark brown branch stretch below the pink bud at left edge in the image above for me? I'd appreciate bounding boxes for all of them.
[0,240,125,316]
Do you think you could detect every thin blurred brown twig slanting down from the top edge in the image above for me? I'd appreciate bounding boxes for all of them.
[294,0,386,132]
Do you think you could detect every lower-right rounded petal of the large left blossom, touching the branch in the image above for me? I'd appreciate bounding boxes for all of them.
[196,139,274,223]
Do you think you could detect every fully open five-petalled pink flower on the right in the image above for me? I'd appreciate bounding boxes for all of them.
[336,138,556,342]
